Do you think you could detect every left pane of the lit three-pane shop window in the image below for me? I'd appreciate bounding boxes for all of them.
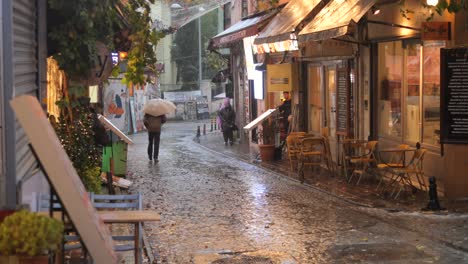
[378,41,403,137]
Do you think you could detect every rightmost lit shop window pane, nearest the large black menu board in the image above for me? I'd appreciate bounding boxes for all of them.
[422,42,445,145]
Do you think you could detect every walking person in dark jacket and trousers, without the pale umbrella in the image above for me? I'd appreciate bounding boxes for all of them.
[143,114,166,162]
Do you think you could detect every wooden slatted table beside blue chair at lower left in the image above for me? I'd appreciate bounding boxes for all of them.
[98,210,161,263]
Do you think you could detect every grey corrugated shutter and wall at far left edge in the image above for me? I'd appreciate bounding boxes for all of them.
[0,0,47,207]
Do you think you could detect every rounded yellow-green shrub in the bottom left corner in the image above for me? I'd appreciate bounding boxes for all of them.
[0,210,64,256]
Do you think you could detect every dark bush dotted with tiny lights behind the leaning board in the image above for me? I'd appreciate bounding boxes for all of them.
[56,94,101,193]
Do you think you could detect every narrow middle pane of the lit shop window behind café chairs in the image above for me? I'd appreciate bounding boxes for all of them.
[403,43,421,142]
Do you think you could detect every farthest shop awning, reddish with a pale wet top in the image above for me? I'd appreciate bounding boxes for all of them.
[210,10,277,48]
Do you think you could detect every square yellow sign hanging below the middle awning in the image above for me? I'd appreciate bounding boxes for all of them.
[267,63,298,92]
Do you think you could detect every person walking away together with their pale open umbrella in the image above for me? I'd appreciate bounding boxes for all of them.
[143,98,176,162]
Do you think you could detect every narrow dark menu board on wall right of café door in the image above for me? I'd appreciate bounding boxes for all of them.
[336,68,350,136]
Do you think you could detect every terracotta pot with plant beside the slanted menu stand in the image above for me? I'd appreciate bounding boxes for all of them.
[258,117,277,161]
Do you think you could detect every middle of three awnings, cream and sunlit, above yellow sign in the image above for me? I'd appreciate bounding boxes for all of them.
[254,0,329,44]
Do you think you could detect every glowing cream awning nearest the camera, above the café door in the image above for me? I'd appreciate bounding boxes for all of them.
[298,0,376,42]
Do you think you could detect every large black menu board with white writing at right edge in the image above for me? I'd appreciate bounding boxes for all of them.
[440,48,468,144]
